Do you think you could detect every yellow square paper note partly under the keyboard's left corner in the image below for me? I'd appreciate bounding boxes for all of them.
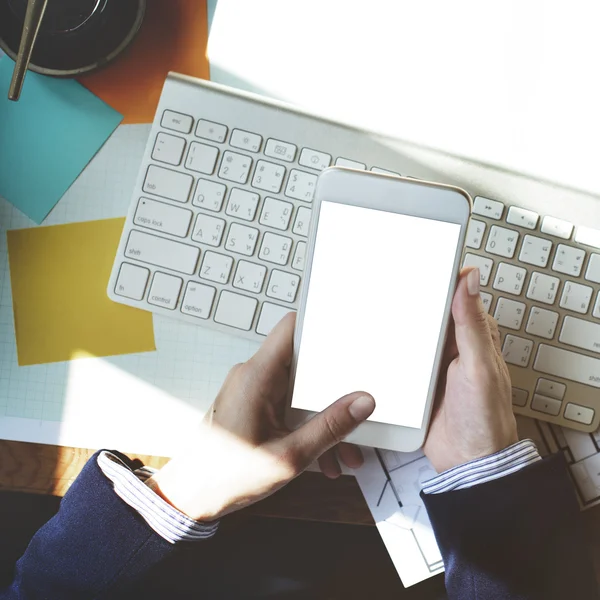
[6,219,156,366]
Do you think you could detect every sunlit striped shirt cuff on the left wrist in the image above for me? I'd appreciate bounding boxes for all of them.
[97,450,219,544]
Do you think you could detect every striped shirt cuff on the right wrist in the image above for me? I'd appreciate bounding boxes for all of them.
[423,440,542,494]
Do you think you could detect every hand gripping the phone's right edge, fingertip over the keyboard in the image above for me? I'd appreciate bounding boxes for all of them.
[424,269,518,473]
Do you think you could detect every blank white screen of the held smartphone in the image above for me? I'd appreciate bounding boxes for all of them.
[292,201,460,428]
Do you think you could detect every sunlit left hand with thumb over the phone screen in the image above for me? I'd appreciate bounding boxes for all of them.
[149,314,375,521]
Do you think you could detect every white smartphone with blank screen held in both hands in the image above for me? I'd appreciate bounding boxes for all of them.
[286,167,471,452]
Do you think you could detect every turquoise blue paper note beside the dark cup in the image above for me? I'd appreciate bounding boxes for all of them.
[0,56,123,223]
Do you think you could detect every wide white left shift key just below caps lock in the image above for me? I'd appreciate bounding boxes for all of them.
[125,230,200,275]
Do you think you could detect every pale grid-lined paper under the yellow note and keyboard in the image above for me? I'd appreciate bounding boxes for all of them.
[0,125,256,455]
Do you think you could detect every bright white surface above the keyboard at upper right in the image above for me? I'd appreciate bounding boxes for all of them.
[209,0,600,194]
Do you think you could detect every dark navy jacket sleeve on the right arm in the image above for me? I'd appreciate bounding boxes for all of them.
[422,454,600,600]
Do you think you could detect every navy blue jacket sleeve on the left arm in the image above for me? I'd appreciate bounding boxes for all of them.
[0,453,183,600]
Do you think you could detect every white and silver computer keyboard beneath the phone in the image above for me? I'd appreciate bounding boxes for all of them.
[108,74,600,431]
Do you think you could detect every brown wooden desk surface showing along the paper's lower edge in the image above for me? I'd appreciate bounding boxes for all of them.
[0,440,600,583]
